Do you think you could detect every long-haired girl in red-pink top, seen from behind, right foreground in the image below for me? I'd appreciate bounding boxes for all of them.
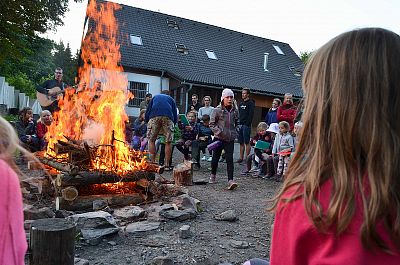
[270,28,400,265]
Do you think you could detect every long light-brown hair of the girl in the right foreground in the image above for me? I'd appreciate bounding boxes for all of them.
[270,28,400,251]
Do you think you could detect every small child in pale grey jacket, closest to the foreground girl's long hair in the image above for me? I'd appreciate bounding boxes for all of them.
[272,121,294,181]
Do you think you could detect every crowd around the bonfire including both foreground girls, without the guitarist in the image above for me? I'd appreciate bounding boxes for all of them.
[0,28,400,265]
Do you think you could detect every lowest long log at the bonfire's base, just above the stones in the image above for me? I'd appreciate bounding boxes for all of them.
[60,193,144,211]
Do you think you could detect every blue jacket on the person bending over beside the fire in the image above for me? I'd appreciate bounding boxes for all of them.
[145,94,178,124]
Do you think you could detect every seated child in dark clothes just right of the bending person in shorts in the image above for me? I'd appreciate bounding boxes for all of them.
[176,111,199,160]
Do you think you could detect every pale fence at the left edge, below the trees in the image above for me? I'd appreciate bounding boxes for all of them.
[0,76,42,115]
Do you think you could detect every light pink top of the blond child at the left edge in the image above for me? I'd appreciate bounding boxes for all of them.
[0,159,27,265]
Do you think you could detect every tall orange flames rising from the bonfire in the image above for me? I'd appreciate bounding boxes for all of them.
[47,0,145,173]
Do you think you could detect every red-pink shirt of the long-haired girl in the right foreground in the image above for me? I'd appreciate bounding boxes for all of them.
[271,178,400,265]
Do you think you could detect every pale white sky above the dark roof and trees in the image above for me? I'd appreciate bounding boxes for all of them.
[47,0,400,54]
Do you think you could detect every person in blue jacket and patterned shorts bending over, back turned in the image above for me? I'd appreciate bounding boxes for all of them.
[145,90,178,171]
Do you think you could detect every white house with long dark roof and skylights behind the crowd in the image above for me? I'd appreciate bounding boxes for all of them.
[86,0,304,123]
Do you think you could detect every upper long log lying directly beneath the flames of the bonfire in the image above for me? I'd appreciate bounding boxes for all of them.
[58,171,155,187]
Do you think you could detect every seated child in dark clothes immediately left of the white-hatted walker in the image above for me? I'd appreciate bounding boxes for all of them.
[192,114,213,168]
